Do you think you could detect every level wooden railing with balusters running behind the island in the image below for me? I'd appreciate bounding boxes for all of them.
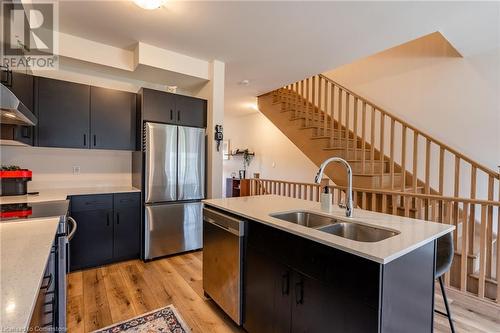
[250,179,500,303]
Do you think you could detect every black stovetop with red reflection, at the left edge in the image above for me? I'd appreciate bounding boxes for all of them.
[0,200,69,222]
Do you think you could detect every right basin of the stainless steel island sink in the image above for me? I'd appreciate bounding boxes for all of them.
[318,222,399,242]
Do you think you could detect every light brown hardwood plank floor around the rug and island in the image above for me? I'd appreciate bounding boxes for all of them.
[68,252,500,333]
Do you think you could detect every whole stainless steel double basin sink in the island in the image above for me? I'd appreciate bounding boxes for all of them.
[270,211,399,242]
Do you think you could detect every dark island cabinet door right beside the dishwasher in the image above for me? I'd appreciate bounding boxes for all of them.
[243,248,291,333]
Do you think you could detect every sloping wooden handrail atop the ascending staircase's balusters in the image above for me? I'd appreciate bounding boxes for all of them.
[318,74,500,179]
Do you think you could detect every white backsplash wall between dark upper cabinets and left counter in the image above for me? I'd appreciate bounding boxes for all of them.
[0,146,132,191]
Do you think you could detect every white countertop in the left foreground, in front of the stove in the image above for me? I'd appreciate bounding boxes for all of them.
[0,217,59,332]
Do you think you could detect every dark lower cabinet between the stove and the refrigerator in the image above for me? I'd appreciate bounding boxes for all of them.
[70,192,141,271]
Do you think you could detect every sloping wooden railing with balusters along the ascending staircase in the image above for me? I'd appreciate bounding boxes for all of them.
[274,74,500,202]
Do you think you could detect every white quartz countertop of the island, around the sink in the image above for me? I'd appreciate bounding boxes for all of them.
[203,195,455,264]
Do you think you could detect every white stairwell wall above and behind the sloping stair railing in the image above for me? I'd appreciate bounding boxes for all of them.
[326,34,500,198]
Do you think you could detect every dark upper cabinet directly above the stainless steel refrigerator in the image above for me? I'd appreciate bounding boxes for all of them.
[140,88,207,127]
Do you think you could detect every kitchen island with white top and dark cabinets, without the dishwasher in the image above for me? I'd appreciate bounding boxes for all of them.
[204,195,454,333]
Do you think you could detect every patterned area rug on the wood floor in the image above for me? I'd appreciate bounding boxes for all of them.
[92,305,191,333]
